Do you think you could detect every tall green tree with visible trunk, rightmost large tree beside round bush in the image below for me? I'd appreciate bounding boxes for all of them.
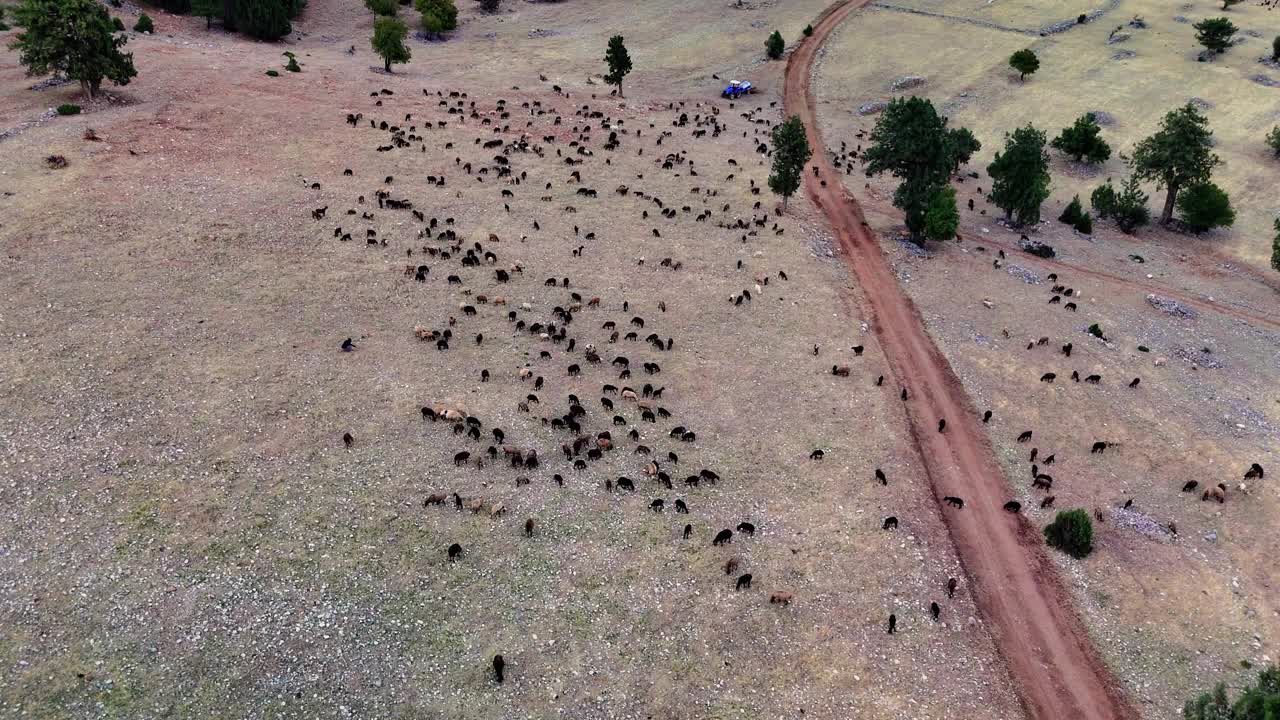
[1133,102,1221,224]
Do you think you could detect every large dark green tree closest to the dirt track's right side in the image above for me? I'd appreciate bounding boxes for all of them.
[863,97,977,242]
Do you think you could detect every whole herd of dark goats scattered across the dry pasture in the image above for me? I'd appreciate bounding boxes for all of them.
[311,81,1263,683]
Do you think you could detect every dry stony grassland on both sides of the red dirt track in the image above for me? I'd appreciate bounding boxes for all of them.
[0,0,1280,719]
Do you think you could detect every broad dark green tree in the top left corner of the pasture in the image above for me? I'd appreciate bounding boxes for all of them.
[9,0,138,100]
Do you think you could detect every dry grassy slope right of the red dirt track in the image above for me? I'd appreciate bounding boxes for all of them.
[815,3,1280,717]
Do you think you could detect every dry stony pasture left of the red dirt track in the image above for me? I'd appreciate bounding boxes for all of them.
[0,1,1020,717]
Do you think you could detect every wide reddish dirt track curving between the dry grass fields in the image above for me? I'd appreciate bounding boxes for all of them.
[786,0,1137,720]
